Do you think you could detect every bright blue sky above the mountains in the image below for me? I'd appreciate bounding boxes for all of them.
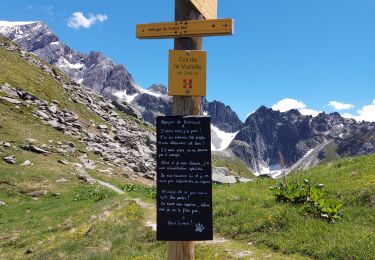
[0,0,375,121]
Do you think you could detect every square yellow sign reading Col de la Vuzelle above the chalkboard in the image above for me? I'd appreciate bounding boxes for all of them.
[168,50,207,97]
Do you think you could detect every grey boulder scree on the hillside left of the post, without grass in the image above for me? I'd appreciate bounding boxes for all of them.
[0,36,156,183]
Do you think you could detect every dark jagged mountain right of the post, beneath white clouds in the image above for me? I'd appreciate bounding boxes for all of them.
[226,106,375,177]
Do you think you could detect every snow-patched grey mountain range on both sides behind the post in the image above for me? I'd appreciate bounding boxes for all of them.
[0,22,375,177]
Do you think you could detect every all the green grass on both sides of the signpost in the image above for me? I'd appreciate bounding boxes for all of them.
[0,35,375,259]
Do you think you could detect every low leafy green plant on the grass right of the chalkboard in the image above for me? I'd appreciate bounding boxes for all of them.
[270,179,342,223]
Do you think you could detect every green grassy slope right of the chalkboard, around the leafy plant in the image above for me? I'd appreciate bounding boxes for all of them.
[214,155,375,259]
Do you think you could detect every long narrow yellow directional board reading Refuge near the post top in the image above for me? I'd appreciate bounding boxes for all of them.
[136,19,234,39]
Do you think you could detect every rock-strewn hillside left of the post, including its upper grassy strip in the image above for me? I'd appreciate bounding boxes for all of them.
[0,35,156,181]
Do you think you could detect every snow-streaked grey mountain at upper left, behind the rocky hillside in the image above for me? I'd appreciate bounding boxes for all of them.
[0,22,138,97]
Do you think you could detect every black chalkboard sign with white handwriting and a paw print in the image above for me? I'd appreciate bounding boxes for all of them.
[156,116,213,241]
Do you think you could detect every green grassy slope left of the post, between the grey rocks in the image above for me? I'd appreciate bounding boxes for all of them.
[0,37,290,259]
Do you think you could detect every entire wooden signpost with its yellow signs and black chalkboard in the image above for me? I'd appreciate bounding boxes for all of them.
[136,0,234,260]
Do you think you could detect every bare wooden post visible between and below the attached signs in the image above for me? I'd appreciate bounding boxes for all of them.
[168,0,203,260]
